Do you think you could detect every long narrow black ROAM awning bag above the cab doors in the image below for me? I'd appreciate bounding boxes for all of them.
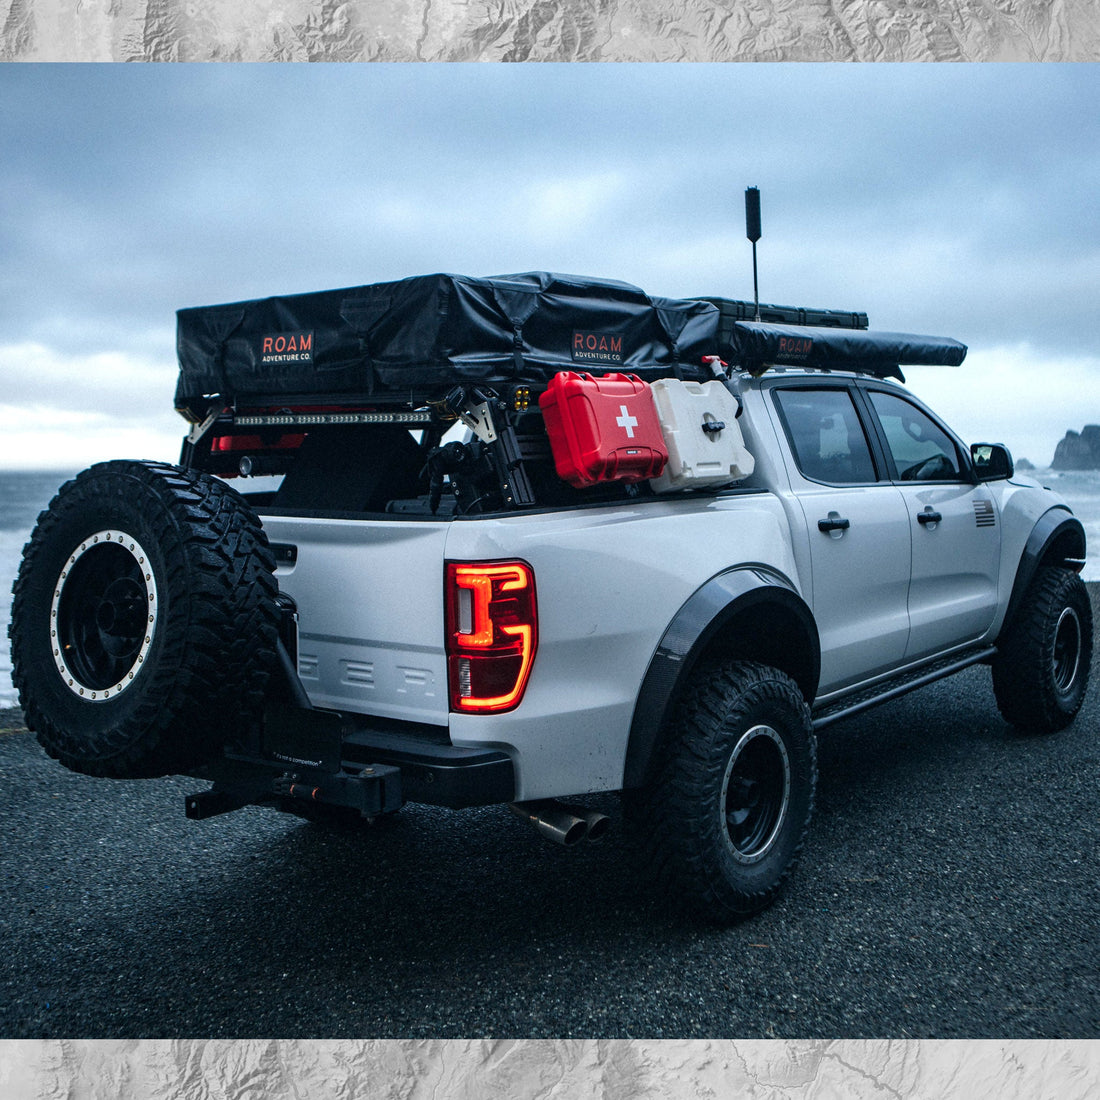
[727,321,967,377]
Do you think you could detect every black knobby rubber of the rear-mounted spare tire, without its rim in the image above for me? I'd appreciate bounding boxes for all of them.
[9,460,277,778]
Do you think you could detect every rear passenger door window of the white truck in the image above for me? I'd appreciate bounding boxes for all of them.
[774,389,876,485]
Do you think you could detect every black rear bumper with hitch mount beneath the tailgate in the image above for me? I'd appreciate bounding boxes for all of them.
[187,707,516,818]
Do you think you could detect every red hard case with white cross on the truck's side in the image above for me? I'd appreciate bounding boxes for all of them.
[539,371,669,488]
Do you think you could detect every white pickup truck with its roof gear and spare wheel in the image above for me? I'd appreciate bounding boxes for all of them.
[11,275,1092,922]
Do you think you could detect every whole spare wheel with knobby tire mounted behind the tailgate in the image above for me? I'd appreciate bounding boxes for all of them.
[9,461,276,778]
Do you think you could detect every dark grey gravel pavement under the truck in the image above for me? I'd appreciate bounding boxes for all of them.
[0,584,1100,1038]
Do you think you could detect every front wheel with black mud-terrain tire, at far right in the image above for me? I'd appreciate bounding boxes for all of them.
[993,567,1092,734]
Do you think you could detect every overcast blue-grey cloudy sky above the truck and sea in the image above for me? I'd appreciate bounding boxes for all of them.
[0,64,1100,469]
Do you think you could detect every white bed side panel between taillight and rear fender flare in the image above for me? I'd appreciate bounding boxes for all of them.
[447,492,799,799]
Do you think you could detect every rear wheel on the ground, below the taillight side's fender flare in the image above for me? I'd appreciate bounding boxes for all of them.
[625,661,817,924]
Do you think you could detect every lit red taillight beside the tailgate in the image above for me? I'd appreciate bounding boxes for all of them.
[447,561,538,714]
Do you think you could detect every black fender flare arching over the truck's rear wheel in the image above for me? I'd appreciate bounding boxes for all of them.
[623,565,821,789]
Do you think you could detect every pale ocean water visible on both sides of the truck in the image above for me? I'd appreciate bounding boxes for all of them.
[0,470,1100,707]
